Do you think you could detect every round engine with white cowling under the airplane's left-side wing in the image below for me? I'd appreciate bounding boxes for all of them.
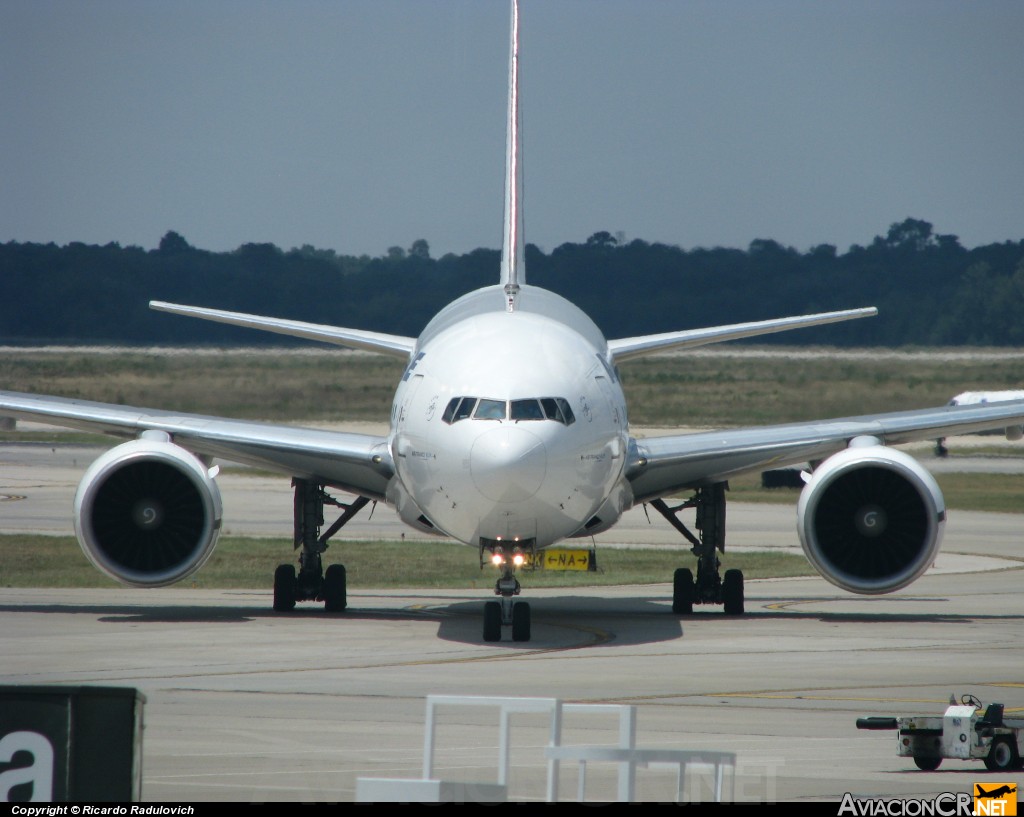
[75,442,221,588]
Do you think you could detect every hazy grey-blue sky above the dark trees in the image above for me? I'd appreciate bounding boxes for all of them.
[0,0,1024,257]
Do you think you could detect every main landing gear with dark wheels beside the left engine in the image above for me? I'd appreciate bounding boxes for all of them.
[273,479,370,612]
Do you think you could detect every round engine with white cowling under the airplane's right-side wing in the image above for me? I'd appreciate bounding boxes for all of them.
[797,440,946,594]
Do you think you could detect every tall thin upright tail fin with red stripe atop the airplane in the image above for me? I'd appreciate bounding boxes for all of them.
[501,0,526,312]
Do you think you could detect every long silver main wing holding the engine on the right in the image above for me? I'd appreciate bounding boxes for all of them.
[627,400,1024,503]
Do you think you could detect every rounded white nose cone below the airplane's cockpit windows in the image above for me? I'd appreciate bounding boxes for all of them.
[469,427,548,502]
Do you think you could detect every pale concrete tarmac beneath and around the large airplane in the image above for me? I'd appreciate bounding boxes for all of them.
[0,438,1024,802]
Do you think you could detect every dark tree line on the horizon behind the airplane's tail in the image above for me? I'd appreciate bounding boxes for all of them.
[0,218,1024,346]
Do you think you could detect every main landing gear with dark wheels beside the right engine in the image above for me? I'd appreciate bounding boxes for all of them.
[650,482,743,615]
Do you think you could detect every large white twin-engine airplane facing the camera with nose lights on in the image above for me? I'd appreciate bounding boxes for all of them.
[0,0,1024,641]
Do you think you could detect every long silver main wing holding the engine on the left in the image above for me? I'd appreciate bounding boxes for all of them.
[0,391,394,500]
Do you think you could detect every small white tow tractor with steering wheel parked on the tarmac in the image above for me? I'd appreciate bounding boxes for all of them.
[857,695,1024,772]
